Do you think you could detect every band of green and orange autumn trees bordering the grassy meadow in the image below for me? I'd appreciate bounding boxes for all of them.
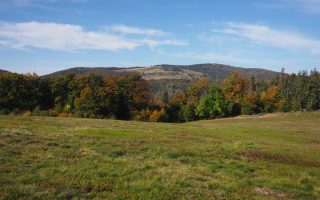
[0,70,320,122]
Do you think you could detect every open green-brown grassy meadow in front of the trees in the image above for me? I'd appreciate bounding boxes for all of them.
[0,112,320,199]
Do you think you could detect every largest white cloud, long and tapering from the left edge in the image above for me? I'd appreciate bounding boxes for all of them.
[0,22,186,51]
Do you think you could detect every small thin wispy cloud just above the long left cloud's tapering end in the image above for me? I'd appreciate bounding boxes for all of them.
[107,24,169,36]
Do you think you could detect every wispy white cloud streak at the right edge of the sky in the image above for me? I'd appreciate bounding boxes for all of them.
[213,23,320,54]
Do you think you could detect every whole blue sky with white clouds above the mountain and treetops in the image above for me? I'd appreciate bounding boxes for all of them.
[0,0,320,75]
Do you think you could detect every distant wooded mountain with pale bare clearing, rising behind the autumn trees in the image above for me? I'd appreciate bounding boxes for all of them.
[1,64,279,101]
